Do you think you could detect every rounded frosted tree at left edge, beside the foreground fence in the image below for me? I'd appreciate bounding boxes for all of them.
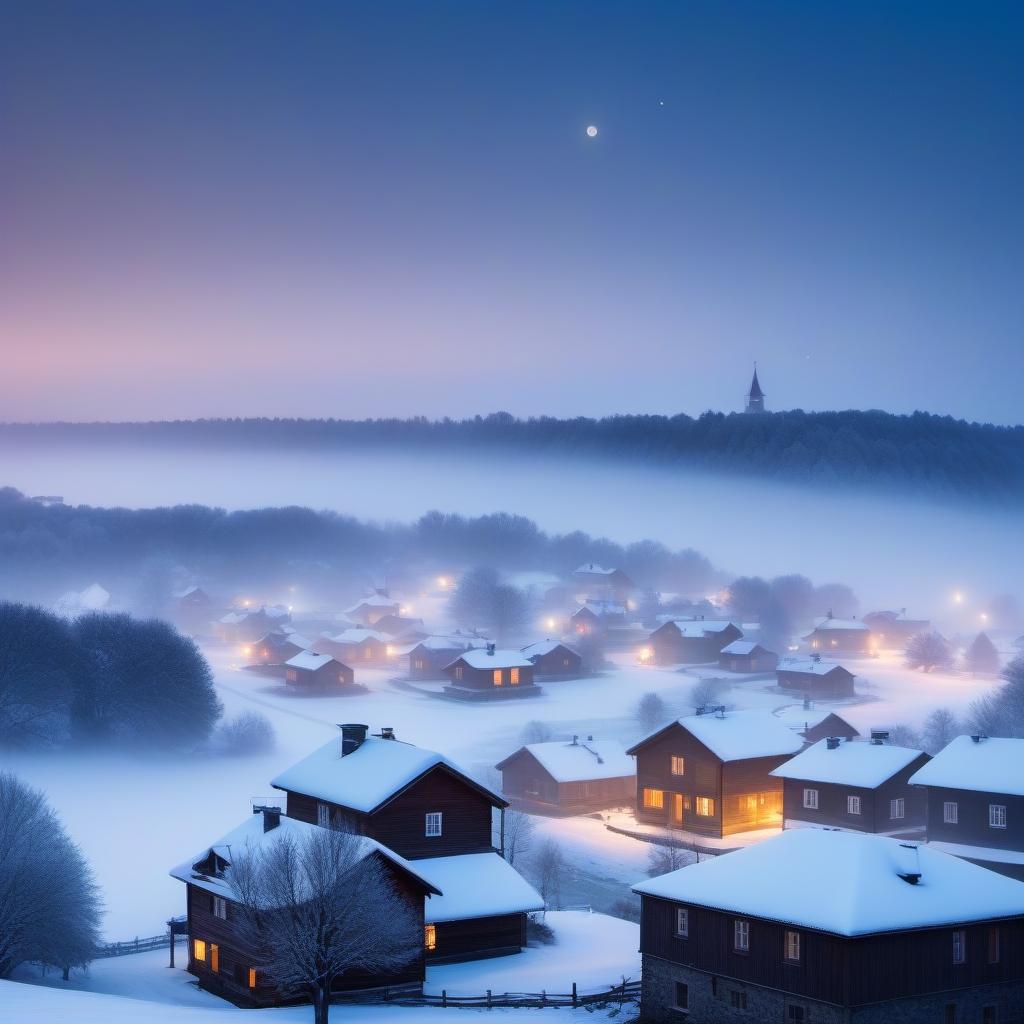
[0,773,101,978]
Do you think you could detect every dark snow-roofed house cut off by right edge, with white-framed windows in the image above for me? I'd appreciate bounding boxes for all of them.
[910,735,1024,880]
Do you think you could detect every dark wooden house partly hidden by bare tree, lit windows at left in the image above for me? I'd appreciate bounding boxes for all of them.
[171,808,438,1007]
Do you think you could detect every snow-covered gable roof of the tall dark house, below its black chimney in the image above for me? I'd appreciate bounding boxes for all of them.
[270,733,505,814]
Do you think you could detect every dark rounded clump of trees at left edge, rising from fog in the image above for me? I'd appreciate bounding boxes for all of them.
[0,602,221,751]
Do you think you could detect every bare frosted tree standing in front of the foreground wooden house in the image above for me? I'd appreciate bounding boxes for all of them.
[229,828,423,1024]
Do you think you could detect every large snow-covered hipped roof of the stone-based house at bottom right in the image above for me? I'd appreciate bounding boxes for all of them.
[633,828,1024,936]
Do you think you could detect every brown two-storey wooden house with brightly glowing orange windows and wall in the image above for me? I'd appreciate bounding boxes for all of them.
[627,708,804,839]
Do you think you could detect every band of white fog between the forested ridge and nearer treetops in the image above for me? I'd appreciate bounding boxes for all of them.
[0,445,1024,614]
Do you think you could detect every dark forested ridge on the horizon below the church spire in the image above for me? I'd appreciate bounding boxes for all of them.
[0,410,1024,500]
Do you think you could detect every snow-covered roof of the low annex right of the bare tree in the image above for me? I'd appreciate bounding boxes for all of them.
[417,853,544,925]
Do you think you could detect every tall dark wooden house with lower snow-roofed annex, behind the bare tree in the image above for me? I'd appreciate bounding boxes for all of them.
[271,725,544,961]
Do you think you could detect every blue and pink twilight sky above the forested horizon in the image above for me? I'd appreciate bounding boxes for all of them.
[0,0,1024,422]
